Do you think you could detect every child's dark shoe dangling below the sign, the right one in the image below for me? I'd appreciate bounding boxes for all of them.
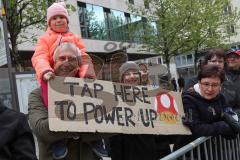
[90,140,108,157]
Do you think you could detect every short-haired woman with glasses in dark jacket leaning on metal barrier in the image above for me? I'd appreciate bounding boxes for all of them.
[182,65,238,138]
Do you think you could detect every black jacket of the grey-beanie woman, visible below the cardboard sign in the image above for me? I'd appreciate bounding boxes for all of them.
[110,134,160,160]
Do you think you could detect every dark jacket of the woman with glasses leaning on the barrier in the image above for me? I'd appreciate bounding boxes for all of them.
[183,91,235,138]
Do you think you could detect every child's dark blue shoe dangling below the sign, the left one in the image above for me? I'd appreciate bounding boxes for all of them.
[52,141,68,159]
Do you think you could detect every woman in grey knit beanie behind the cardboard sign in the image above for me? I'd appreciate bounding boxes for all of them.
[109,61,159,160]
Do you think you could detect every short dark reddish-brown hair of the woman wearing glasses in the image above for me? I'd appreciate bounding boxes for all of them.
[198,64,225,83]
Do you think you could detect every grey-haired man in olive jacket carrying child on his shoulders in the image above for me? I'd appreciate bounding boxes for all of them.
[28,43,109,160]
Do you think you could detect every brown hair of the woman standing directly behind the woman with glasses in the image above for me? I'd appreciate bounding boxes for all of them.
[200,48,225,68]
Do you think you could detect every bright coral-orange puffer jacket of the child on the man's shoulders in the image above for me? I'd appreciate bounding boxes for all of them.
[32,28,96,84]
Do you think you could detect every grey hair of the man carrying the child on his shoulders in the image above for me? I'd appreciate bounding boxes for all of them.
[53,42,81,62]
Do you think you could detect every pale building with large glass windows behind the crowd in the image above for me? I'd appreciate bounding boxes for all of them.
[16,0,176,84]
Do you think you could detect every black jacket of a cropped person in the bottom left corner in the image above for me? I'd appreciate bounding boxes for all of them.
[0,105,37,160]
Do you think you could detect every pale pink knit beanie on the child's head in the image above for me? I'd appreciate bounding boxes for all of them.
[47,2,69,24]
